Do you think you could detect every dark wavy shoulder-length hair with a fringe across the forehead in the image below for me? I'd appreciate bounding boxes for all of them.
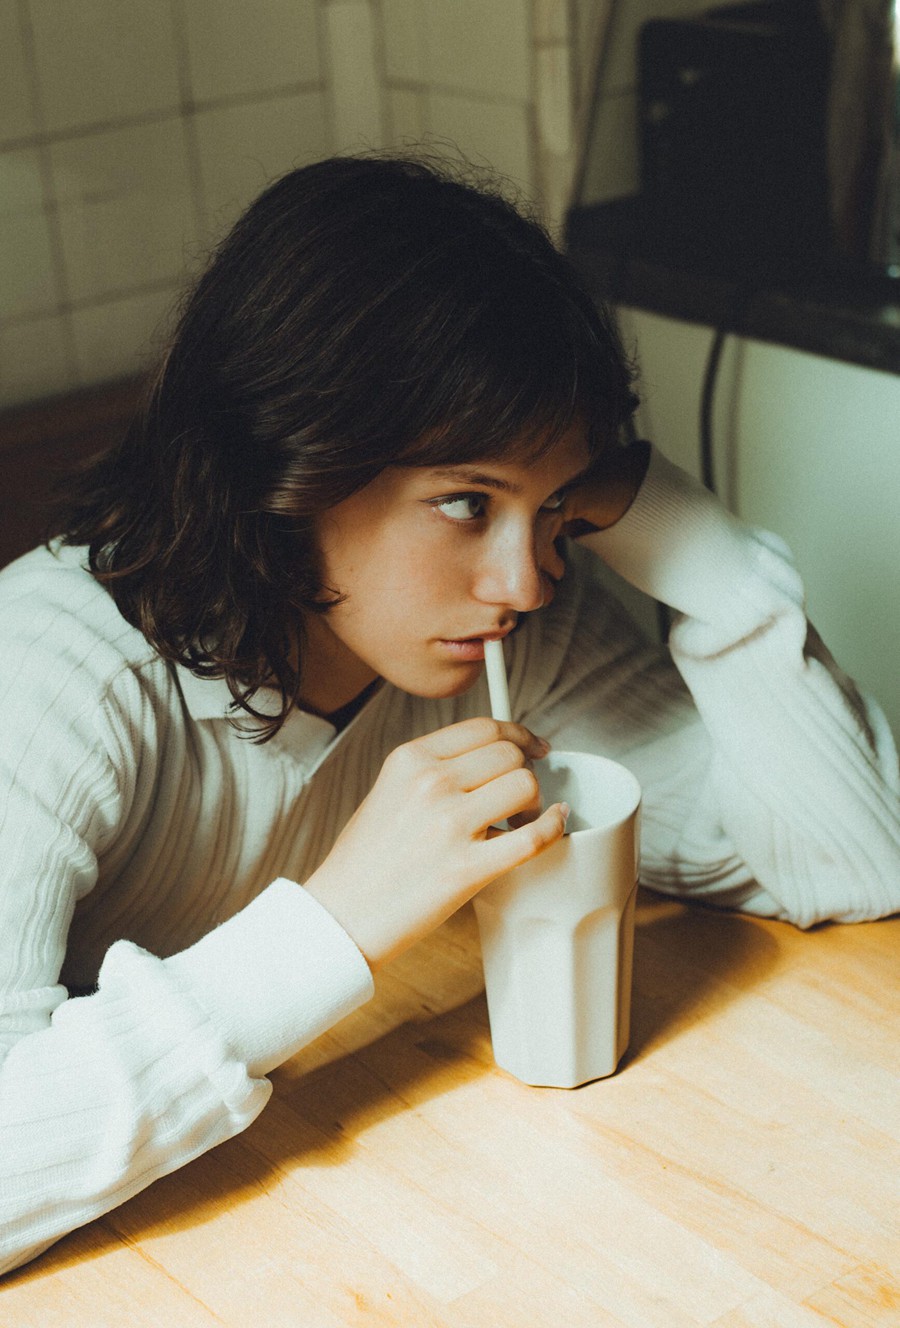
[57,155,636,740]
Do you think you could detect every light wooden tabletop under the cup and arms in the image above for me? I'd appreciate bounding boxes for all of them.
[0,896,900,1328]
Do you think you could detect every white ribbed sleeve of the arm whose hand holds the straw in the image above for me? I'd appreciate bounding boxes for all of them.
[0,626,372,1274]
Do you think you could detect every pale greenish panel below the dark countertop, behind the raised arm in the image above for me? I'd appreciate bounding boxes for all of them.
[620,309,900,742]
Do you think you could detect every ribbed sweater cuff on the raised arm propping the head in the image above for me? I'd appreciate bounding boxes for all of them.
[580,448,803,653]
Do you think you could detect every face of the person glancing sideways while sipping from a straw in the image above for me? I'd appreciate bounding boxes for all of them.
[303,428,589,713]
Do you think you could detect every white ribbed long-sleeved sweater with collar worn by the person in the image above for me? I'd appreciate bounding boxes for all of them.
[0,453,900,1272]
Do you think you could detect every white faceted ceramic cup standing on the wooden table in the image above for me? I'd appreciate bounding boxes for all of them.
[475,752,641,1088]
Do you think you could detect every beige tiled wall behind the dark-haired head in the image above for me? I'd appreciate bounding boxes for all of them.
[0,0,589,406]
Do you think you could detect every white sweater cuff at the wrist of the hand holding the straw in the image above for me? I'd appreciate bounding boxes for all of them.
[163,878,374,1077]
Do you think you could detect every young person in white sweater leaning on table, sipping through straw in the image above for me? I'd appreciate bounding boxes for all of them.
[0,158,900,1270]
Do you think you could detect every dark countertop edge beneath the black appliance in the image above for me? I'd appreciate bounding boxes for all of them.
[565,198,900,373]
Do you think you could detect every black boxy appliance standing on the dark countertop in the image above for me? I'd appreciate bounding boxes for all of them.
[638,0,830,280]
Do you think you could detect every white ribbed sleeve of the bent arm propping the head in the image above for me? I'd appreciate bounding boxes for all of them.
[584,452,900,927]
